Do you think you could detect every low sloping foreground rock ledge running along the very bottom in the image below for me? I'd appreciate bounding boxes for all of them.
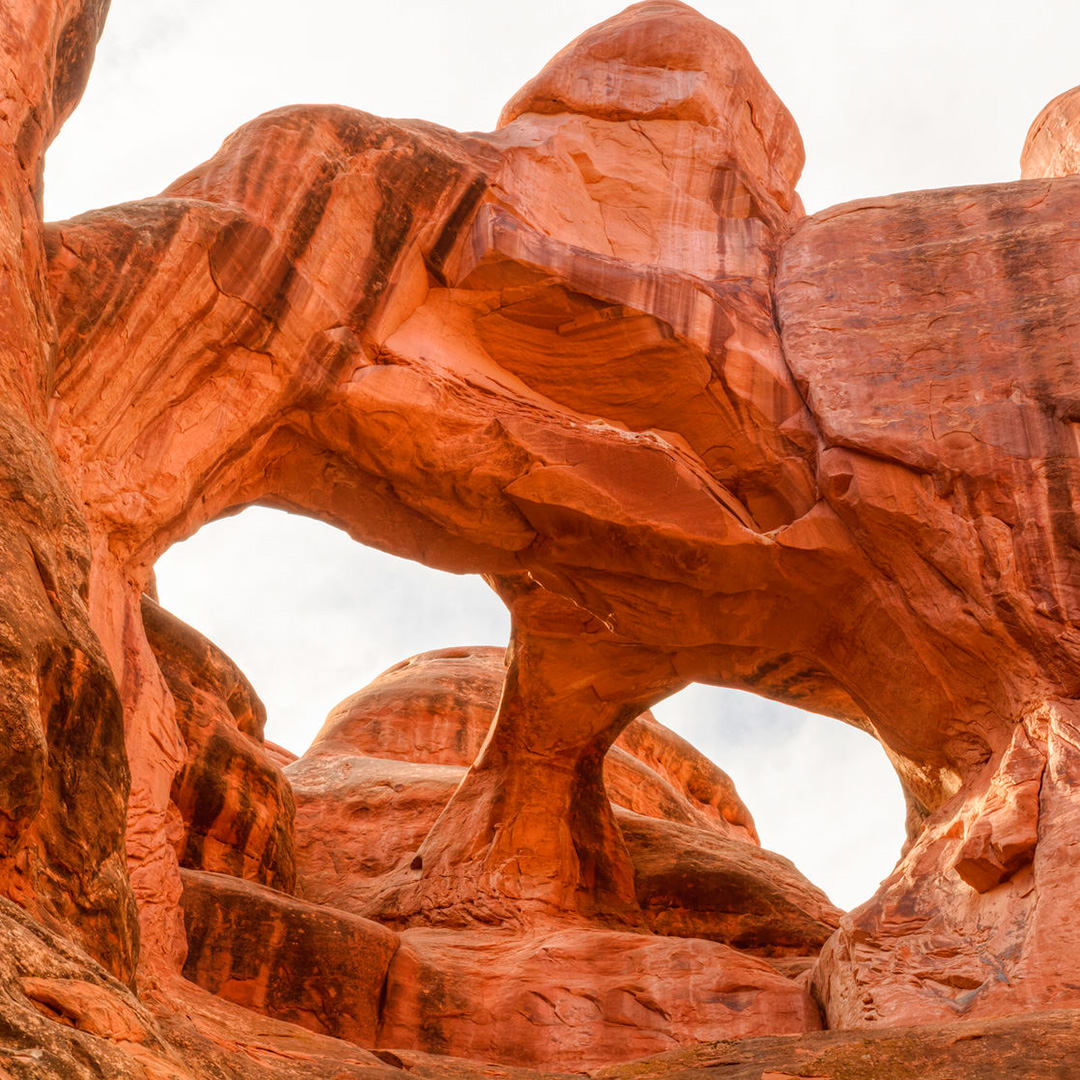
[0,881,1080,1080]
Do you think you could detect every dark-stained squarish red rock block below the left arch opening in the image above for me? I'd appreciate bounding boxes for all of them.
[183,870,397,1045]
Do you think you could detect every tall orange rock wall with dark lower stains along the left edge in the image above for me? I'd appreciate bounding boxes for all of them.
[0,0,137,980]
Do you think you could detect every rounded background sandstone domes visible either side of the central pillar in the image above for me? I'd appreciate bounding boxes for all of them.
[287,648,825,956]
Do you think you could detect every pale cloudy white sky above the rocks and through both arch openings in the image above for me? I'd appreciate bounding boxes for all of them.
[45,0,1080,907]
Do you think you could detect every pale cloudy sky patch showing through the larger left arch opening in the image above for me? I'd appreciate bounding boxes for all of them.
[156,507,510,755]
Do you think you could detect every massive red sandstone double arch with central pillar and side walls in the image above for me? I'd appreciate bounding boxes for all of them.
[6,0,1080,1067]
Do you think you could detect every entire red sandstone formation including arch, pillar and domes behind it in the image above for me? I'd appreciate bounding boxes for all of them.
[6,0,1080,1077]
